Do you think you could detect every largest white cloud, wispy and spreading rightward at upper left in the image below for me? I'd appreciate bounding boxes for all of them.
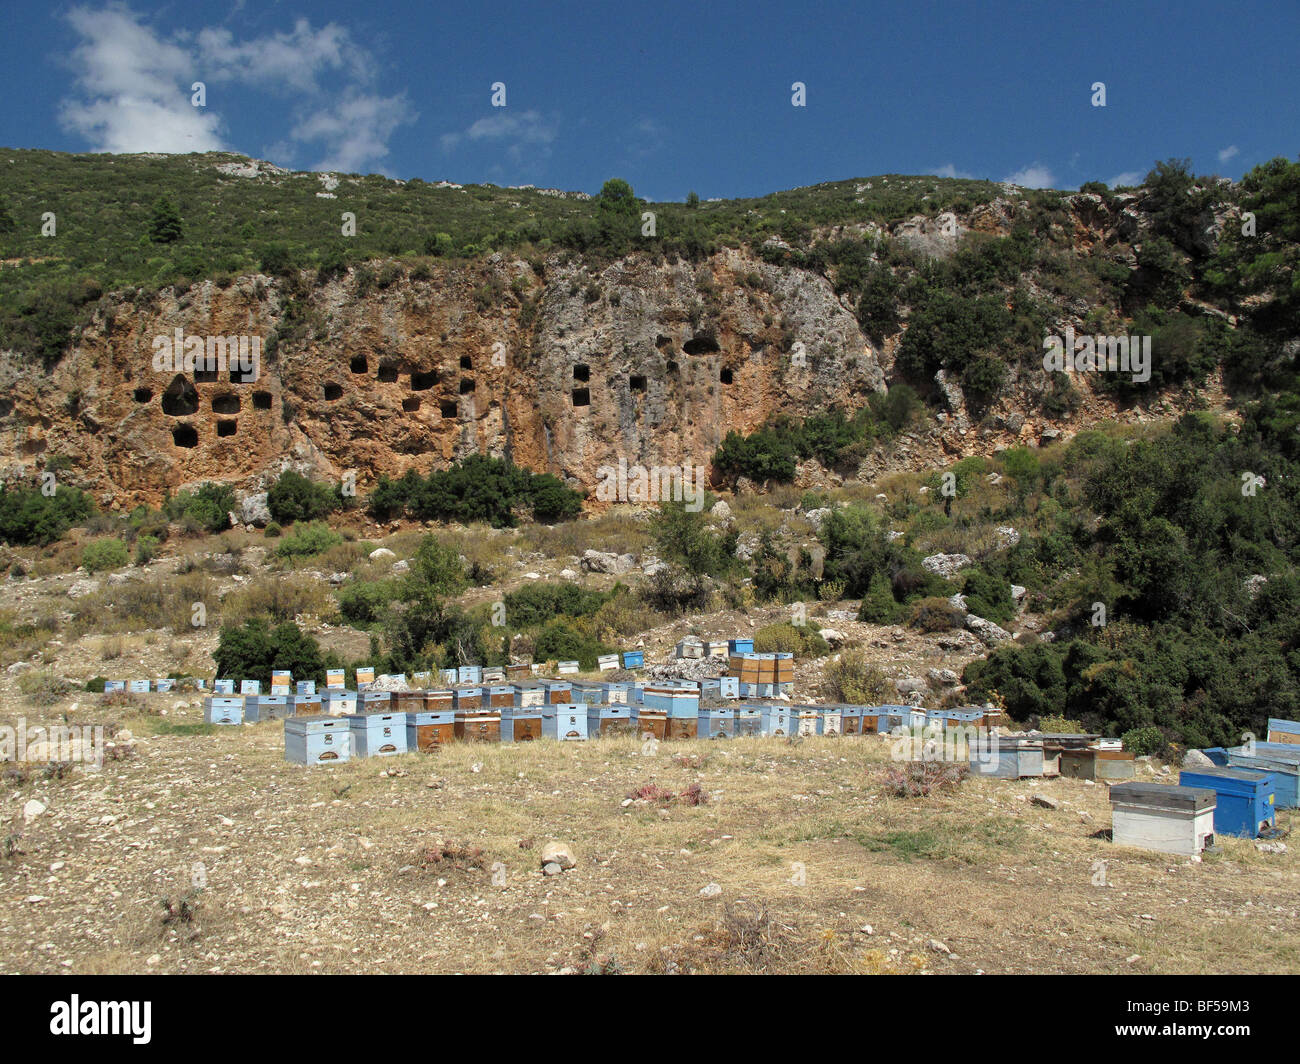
[60,5,416,170]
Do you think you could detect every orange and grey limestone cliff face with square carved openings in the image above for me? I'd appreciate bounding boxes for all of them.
[0,250,885,512]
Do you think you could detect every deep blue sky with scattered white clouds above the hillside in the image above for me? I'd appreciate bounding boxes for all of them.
[0,0,1300,200]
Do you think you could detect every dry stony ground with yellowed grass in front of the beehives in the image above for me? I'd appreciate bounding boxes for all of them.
[0,693,1300,973]
